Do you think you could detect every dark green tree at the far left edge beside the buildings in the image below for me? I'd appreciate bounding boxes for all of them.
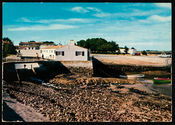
[2,37,17,57]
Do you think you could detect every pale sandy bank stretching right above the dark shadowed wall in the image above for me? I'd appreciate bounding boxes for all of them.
[93,55,172,66]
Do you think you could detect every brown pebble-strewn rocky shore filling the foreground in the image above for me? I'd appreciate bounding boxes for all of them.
[4,75,172,122]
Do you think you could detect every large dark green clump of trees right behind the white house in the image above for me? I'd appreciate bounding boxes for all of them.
[77,38,119,53]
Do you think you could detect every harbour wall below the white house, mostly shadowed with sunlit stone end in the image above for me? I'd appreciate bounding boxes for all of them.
[3,61,93,81]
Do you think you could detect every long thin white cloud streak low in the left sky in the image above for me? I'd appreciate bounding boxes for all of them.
[7,24,77,31]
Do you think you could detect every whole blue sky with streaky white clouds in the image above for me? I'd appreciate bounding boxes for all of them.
[2,2,172,50]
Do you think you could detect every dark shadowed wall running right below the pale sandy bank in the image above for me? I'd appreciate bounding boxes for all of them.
[93,58,171,77]
